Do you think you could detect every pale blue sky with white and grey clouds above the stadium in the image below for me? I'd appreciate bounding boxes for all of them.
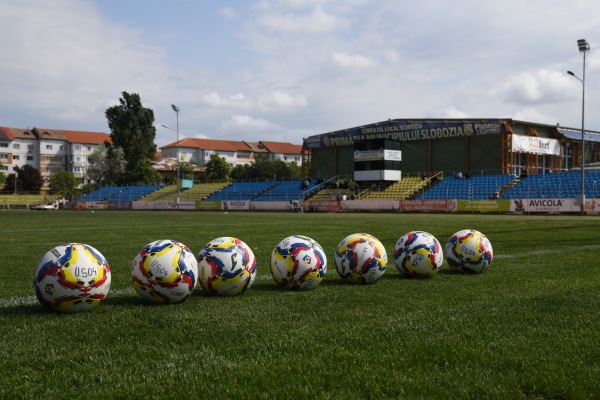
[0,0,600,147]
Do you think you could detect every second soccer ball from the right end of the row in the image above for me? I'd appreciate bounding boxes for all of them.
[394,231,444,278]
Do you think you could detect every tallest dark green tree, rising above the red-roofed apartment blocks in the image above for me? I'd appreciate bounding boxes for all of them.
[106,92,156,184]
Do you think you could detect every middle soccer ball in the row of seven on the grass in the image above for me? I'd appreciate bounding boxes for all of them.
[271,235,327,290]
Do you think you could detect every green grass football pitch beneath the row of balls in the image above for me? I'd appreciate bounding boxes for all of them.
[0,210,600,399]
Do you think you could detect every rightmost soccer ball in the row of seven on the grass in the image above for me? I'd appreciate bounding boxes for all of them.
[446,229,494,274]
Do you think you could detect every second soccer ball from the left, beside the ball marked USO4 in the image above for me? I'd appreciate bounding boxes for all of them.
[131,240,198,304]
